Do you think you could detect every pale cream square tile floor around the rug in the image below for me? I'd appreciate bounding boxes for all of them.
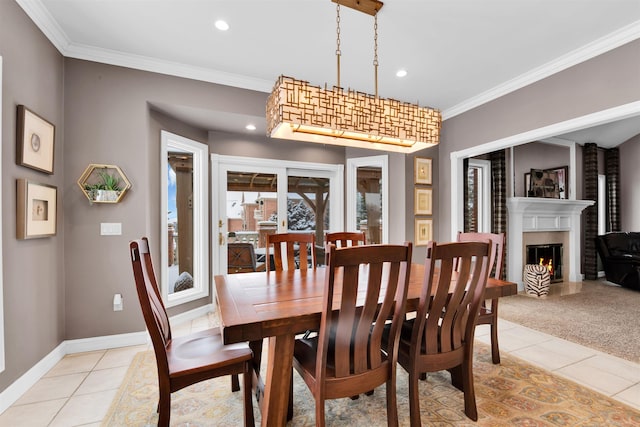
[0,314,640,427]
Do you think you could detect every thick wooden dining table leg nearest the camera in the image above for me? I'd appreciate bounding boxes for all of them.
[262,335,295,426]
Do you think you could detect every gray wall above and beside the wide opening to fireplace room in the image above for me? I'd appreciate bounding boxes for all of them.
[437,40,640,241]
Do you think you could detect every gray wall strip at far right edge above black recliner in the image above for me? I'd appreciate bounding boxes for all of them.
[620,135,640,231]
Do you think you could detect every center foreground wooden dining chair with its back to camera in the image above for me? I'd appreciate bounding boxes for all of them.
[293,243,412,426]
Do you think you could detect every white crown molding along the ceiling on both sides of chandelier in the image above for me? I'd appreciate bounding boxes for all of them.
[16,0,640,120]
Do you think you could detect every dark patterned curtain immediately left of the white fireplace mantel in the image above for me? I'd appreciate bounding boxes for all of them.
[489,150,509,279]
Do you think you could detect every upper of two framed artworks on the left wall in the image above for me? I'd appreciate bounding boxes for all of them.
[16,105,55,175]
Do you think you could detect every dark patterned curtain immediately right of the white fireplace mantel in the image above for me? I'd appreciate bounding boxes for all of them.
[582,143,598,280]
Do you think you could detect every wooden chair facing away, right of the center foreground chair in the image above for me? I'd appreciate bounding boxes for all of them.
[383,241,491,427]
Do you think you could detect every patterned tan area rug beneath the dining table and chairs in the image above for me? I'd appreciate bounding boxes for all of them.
[102,343,640,427]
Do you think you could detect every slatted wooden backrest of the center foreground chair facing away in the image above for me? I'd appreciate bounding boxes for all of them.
[316,243,411,378]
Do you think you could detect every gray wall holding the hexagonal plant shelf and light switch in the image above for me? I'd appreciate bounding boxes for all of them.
[65,59,344,339]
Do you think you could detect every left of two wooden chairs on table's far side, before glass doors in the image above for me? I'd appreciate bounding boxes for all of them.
[265,233,317,271]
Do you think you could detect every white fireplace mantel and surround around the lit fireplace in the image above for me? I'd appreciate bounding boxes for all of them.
[507,197,595,290]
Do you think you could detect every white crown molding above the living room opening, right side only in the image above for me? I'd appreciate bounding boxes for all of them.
[442,21,640,120]
